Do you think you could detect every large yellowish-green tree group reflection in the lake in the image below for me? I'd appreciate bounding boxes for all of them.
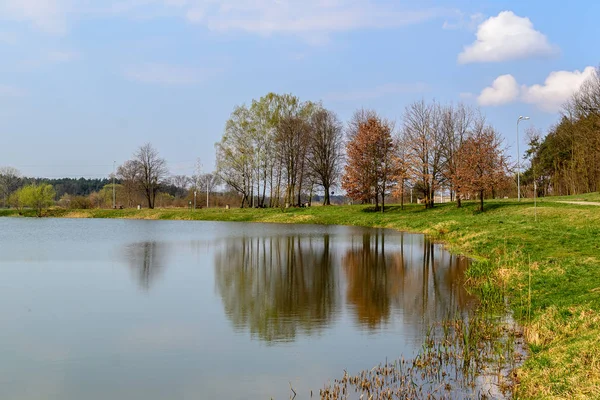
[215,235,337,342]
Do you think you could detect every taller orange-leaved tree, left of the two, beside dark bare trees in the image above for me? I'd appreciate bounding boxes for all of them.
[342,113,397,212]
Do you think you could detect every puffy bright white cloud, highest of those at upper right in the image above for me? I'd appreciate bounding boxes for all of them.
[458,11,557,64]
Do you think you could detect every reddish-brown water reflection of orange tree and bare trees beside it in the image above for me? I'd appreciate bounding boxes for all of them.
[342,230,473,330]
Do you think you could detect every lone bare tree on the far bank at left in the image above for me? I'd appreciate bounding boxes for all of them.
[133,143,169,208]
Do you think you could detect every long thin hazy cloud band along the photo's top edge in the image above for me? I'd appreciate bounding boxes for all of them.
[0,0,440,42]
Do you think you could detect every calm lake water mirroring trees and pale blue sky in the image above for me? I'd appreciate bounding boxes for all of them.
[0,218,473,400]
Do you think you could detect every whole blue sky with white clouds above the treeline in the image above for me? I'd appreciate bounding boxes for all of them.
[0,0,600,178]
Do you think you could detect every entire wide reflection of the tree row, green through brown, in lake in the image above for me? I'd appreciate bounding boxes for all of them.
[214,230,473,342]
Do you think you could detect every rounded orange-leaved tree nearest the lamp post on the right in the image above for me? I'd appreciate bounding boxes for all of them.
[453,126,507,211]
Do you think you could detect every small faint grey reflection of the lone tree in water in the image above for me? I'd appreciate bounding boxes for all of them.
[125,242,168,290]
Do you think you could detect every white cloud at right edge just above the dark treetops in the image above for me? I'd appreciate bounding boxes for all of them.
[521,67,596,112]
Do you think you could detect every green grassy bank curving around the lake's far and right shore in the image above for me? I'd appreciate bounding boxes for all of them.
[0,198,600,398]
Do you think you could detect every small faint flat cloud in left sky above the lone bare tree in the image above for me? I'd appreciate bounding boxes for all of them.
[125,64,212,86]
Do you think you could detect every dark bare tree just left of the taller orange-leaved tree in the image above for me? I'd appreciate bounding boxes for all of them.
[307,109,343,205]
